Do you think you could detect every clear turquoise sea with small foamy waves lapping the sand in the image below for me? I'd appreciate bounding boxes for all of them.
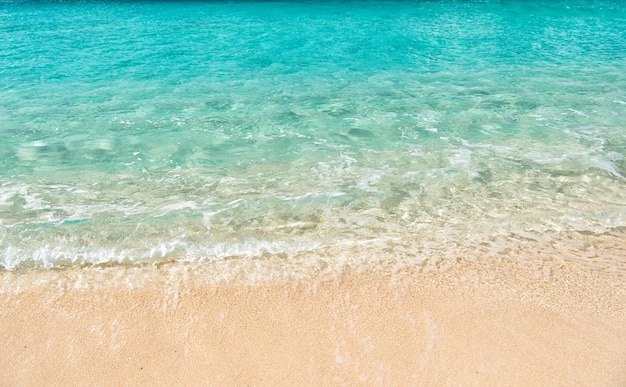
[0,1,626,271]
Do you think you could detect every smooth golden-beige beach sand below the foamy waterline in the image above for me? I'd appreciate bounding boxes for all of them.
[0,260,626,386]
